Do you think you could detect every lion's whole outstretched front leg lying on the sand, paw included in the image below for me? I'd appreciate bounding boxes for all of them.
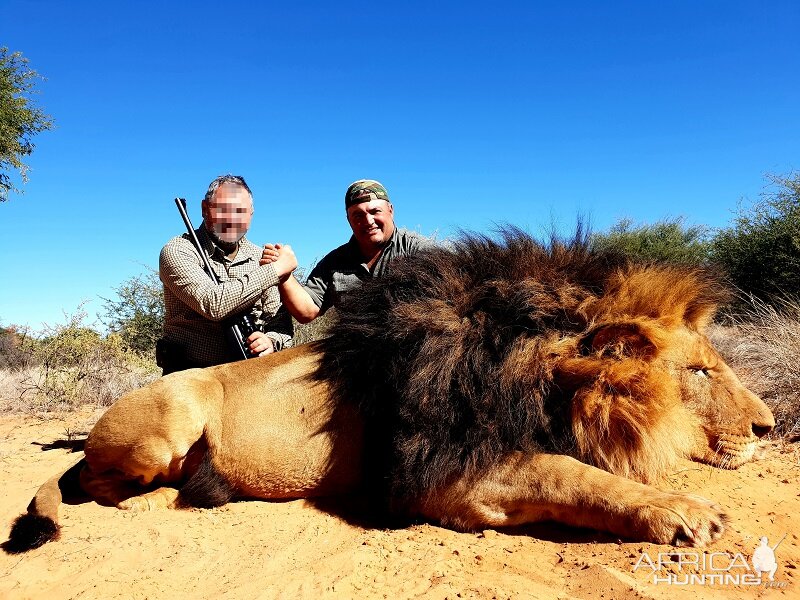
[418,453,726,546]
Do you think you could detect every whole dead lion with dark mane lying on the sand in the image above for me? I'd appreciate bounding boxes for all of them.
[4,229,775,552]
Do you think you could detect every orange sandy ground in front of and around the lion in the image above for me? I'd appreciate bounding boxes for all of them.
[0,413,800,600]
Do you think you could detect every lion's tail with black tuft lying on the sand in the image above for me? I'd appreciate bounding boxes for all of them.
[2,457,85,554]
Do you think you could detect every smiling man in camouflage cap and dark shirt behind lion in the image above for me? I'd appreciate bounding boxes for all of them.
[261,179,433,323]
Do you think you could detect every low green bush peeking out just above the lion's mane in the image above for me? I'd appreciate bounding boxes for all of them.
[591,218,710,264]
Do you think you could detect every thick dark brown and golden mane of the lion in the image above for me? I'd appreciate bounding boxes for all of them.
[315,228,725,508]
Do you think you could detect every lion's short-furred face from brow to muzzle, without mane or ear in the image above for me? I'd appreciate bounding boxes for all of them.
[662,328,775,469]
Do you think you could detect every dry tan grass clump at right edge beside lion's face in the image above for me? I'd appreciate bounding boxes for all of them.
[710,298,800,441]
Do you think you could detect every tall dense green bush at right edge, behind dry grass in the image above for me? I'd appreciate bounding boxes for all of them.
[712,173,800,299]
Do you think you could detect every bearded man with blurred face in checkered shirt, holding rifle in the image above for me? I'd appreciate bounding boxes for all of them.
[157,175,297,375]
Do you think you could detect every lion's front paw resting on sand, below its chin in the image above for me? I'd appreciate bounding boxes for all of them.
[636,492,728,546]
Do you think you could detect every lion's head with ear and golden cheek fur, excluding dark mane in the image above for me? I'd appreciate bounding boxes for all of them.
[556,317,775,482]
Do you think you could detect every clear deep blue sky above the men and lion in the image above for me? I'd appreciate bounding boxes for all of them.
[0,0,800,327]
